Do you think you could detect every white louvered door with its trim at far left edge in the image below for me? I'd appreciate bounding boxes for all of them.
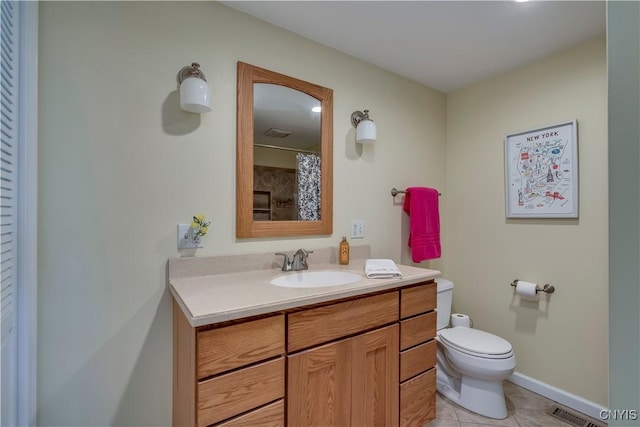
[0,0,39,426]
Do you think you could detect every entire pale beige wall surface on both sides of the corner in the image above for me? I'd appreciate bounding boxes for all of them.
[38,2,608,425]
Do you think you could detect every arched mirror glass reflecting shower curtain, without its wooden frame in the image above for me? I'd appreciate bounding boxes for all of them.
[253,83,322,221]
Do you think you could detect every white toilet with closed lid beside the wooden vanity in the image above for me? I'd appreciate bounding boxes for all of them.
[436,278,516,419]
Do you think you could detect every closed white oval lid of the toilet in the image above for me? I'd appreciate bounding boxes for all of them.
[438,326,512,357]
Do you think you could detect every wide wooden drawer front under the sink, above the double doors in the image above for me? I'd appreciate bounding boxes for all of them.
[288,291,399,352]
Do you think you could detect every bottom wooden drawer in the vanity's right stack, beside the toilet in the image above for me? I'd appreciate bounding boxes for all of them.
[400,368,436,427]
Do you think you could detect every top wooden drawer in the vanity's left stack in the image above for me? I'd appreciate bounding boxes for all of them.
[198,315,284,379]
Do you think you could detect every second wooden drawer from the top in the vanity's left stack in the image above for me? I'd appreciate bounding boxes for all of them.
[197,357,284,426]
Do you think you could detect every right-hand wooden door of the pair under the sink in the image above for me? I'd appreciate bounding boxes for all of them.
[351,325,399,427]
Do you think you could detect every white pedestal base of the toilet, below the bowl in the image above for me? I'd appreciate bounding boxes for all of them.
[436,369,507,419]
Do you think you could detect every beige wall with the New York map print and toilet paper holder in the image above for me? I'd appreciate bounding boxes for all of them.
[443,37,608,405]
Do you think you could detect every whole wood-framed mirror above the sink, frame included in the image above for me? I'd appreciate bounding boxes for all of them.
[236,62,333,238]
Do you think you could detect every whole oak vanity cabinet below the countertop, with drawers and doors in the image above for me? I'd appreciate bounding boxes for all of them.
[173,280,436,427]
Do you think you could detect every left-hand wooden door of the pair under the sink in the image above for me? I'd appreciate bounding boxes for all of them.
[287,339,352,427]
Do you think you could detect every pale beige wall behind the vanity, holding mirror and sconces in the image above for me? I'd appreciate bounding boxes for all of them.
[38,2,446,426]
